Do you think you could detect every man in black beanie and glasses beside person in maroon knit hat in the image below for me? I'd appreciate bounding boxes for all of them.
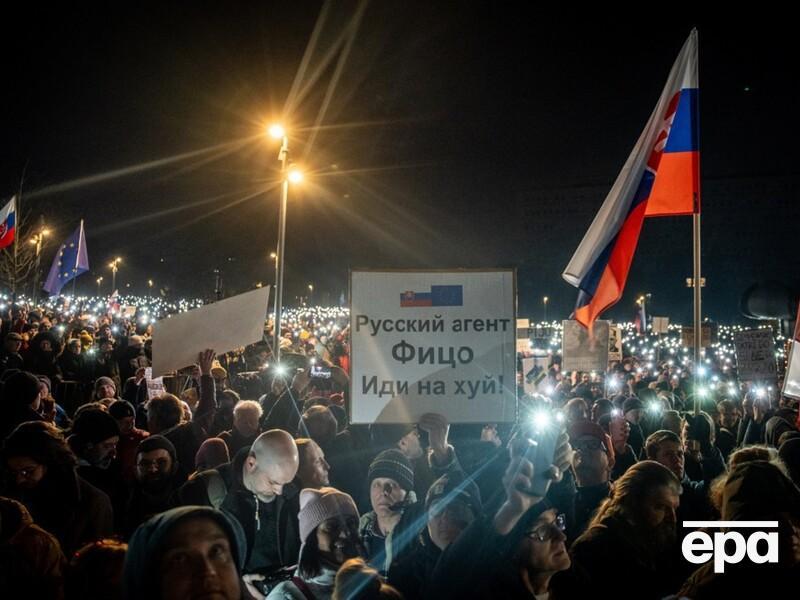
[122,435,181,537]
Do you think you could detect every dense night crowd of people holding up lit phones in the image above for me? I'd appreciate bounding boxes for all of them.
[0,305,800,600]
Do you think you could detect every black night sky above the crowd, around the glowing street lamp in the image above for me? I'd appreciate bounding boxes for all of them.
[0,1,800,321]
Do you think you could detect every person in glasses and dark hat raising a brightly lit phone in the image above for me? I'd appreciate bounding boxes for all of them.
[428,434,572,600]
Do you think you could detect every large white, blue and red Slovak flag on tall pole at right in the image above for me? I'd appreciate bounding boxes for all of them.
[562,29,700,330]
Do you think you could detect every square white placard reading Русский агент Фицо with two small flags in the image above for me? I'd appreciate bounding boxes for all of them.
[350,270,516,423]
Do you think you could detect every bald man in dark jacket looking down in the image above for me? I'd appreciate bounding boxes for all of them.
[221,429,300,574]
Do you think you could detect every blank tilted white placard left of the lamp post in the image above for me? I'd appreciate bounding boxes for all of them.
[153,286,269,375]
